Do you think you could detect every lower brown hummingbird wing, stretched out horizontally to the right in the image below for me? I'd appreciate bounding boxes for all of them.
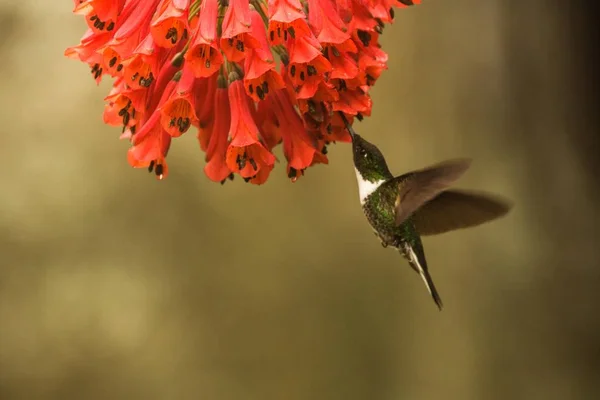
[413,190,512,235]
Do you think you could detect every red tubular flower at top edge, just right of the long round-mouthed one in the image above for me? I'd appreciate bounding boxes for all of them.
[221,0,259,62]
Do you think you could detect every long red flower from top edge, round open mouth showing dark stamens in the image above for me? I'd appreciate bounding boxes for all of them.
[185,0,223,78]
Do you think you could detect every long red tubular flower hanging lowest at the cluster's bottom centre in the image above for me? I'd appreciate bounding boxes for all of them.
[226,77,275,185]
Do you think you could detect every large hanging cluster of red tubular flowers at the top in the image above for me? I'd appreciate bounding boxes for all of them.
[65,0,420,184]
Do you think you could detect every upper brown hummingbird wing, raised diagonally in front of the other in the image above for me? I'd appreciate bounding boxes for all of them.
[394,158,471,225]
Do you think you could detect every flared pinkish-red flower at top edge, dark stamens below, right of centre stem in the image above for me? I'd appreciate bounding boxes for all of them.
[267,0,311,46]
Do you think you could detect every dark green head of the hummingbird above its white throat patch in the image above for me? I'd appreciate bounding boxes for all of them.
[351,132,393,182]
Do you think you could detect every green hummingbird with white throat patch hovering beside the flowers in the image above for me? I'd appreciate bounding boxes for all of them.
[342,115,512,310]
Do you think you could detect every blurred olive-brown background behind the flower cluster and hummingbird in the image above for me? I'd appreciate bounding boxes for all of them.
[0,0,600,400]
